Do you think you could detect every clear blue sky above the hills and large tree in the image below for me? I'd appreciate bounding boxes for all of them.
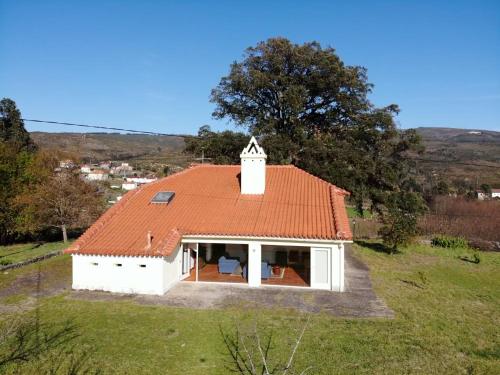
[0,0,500,134]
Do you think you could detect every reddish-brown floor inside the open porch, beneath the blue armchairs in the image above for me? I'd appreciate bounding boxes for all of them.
[184,264,309,287]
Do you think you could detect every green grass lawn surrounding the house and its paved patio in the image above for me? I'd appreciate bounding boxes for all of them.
[0,243,500,374]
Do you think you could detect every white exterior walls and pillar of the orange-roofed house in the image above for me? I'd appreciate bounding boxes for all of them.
[72,238,350,295]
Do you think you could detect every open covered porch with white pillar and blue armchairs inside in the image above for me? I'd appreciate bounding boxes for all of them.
[181,236,345,292]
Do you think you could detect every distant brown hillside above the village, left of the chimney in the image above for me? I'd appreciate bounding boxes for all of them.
[31,132,188,161]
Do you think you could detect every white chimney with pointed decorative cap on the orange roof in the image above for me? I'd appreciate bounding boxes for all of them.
[240,137,267,194]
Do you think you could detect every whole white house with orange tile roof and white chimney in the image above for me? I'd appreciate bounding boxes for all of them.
[66,137,352,295]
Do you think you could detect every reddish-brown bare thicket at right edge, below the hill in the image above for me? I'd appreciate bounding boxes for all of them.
[419,196,500,241]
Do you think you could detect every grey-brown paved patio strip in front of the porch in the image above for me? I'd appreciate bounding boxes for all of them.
[134,250,394,318]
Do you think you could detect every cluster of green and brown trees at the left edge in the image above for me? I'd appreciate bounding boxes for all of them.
[0,98,104,244]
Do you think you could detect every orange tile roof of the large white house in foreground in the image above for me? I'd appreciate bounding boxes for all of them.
[67,165,352,256]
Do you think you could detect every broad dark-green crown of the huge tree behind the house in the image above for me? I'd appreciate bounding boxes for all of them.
[209,38,421,217]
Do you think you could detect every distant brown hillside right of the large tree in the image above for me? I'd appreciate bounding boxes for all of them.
[416,127,500,187]
